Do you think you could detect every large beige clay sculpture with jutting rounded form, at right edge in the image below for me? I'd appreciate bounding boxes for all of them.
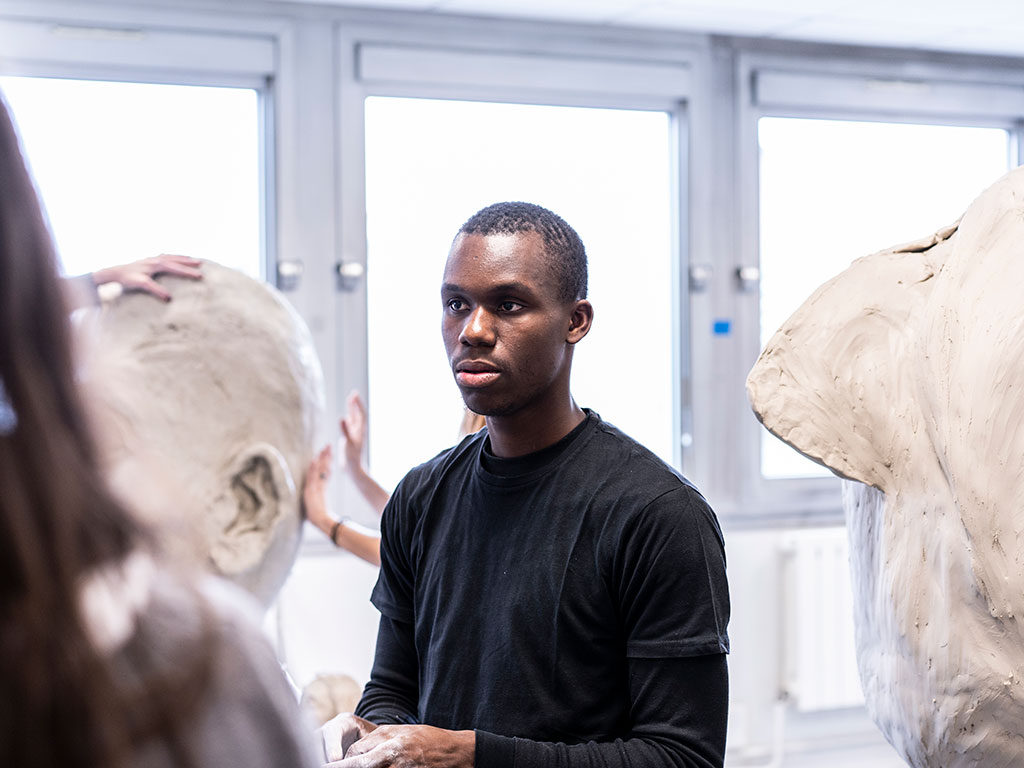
[748,169,1024,768]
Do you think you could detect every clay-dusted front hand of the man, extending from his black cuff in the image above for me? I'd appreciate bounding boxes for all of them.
[325,718,476,768]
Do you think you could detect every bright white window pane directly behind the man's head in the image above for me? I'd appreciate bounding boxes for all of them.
[366,97,673,493]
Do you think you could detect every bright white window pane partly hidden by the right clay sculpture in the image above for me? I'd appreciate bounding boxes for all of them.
[758,118,1010,478]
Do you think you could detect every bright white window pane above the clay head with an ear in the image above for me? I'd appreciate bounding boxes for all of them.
[0,77,262,278]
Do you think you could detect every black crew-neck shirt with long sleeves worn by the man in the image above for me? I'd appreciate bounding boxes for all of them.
[356,413,729,768]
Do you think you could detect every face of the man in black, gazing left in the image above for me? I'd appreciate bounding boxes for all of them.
[441,232,580,417]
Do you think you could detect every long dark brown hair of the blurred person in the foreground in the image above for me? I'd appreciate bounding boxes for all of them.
[0,91,211,768]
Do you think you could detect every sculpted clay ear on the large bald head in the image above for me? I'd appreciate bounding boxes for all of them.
[208,442,298,577]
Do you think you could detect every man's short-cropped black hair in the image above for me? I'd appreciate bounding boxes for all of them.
[459,203,587,301]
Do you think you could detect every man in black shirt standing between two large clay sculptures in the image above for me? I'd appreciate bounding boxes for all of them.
[324,203,729,768]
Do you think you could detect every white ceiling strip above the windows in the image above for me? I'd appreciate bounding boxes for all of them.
[278,0,1024,56]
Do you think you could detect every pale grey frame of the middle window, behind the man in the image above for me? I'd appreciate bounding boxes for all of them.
[336,20,700,483]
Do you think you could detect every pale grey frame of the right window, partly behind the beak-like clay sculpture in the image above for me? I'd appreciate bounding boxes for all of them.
[731,51,1024,526]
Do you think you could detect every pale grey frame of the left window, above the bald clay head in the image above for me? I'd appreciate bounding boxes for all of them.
[0,0,348,528]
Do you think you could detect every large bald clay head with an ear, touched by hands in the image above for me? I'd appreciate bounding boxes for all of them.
[85,262,324,606]
